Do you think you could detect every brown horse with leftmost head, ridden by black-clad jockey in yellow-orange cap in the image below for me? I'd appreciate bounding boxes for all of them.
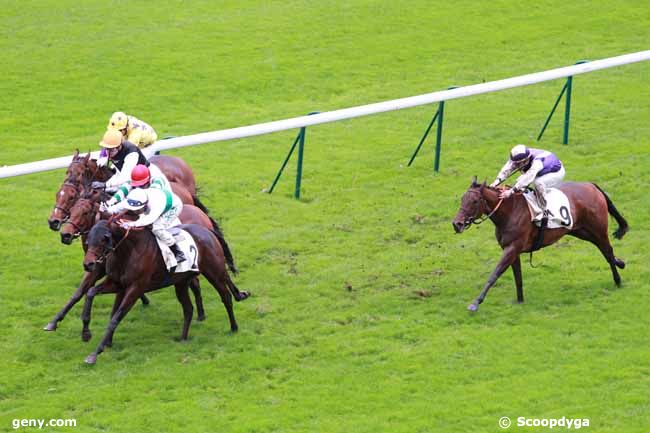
[47,150,197,231]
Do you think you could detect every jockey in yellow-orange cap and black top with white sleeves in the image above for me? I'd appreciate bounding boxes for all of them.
[91,129,162,191]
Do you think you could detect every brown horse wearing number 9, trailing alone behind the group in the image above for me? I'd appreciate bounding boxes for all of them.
[452,178,629,311]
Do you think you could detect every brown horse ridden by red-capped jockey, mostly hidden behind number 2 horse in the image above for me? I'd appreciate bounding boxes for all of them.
[43,194,218,341]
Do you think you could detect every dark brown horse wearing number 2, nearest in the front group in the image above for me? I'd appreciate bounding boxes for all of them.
[83,219,249,364]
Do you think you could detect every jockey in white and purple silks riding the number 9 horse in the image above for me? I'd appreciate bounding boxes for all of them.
[490,144,564,225]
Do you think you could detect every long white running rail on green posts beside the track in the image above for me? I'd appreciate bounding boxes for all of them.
[0,50,650,178]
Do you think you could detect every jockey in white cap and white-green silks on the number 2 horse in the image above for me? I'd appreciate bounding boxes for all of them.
[106,180,186,269]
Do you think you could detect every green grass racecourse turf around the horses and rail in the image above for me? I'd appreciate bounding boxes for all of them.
[0,0,650,433]
